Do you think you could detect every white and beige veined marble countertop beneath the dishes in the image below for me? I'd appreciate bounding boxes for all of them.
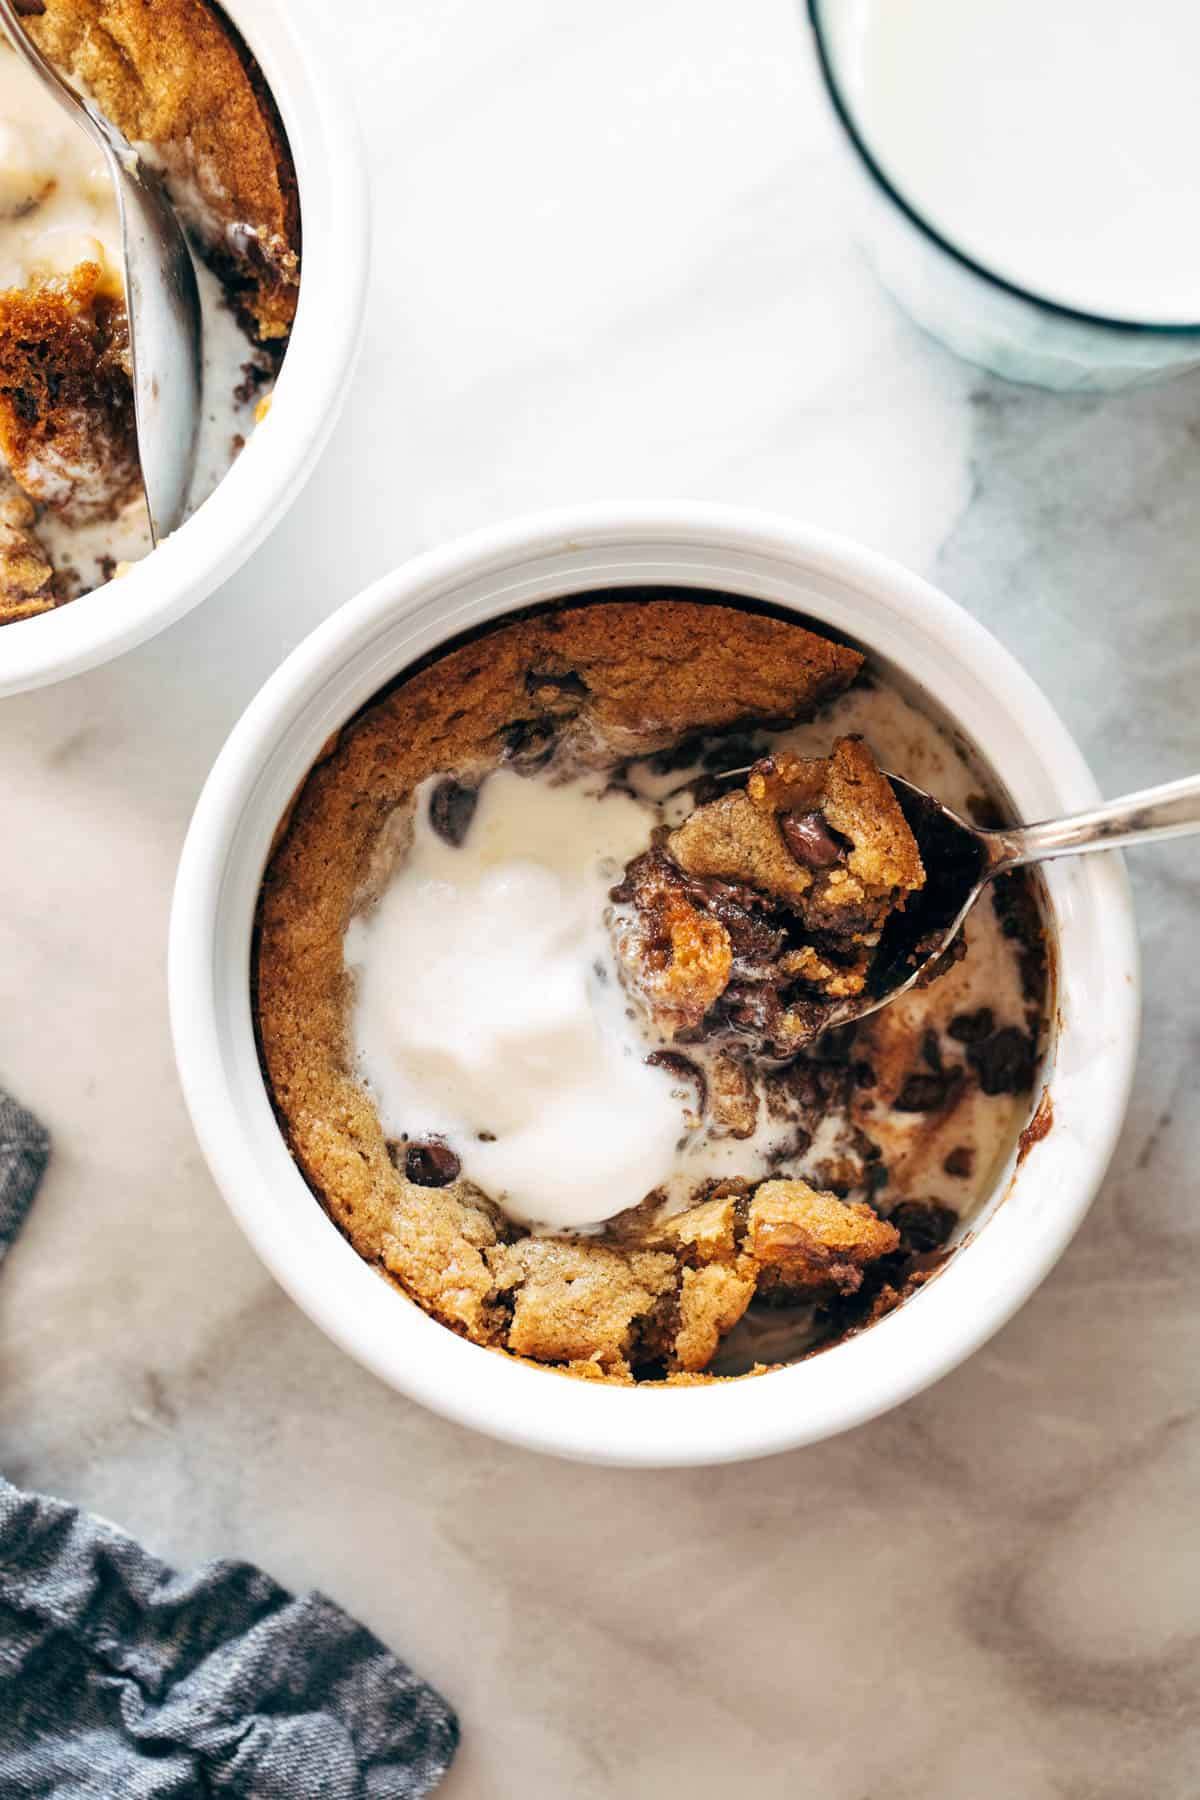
[0,0,1200,1800]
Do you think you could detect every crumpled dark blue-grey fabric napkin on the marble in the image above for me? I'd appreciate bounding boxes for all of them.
[0,1093,459,1800]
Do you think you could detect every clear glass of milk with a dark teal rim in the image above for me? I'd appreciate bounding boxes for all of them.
[808,0,1200,389]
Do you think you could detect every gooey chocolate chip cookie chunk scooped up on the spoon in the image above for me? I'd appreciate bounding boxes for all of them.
[612,738,925,1057]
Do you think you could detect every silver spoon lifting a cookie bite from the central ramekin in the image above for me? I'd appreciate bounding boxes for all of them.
[705,769,1200,1031]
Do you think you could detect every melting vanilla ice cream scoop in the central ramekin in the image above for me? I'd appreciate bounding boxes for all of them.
[345,769,684,1229]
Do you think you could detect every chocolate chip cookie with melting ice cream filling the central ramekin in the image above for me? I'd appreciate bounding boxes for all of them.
[254,590,1042,1382]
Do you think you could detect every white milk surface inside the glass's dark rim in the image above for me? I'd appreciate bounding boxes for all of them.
[841,0,1200,324]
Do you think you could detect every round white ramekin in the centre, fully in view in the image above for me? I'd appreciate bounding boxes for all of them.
[169,504,1139,1465]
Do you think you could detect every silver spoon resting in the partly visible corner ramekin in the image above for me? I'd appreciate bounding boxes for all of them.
[0,0,203,544]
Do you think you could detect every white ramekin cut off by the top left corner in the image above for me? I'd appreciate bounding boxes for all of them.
[0,0,369,698]
